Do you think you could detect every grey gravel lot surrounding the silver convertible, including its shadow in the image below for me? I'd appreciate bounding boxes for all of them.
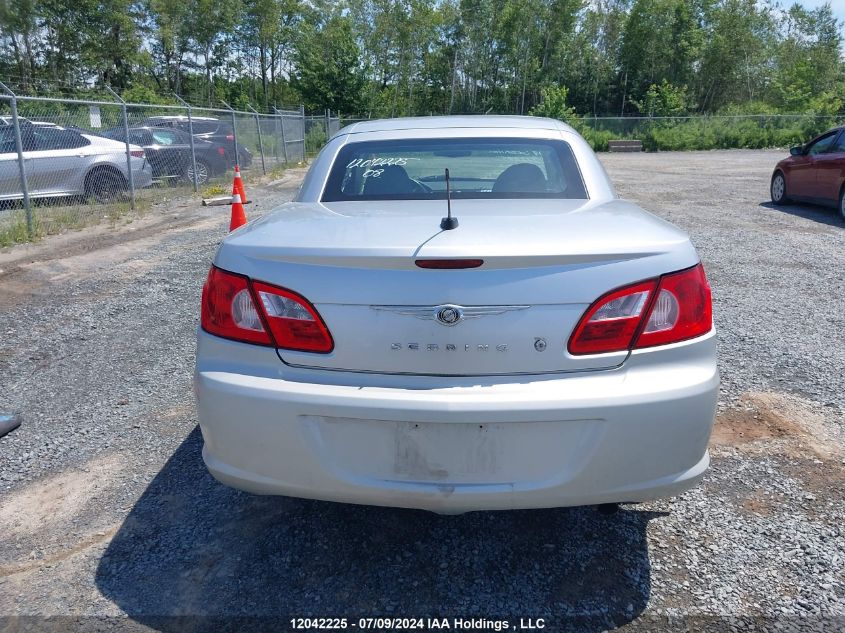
[0,151,845,631]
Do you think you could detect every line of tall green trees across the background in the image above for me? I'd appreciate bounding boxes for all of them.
[0,0,845,118]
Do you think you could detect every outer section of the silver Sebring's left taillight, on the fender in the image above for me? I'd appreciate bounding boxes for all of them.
[200,266,273,345]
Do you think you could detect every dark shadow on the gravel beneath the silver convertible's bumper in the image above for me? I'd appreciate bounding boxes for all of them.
[96,429,660,631]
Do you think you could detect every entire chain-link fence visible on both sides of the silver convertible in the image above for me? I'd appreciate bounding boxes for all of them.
[0,97,842,246]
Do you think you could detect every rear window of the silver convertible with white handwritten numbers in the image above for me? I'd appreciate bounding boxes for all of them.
[322,138,587,202]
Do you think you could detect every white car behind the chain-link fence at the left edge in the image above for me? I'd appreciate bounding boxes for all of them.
[0,120,153,202]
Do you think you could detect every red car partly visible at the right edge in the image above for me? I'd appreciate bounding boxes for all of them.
[771,127,845,220]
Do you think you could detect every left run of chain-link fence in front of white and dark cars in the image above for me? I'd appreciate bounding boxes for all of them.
[0,84,307,246]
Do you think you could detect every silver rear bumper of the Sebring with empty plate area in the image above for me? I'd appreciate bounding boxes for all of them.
[195,331,719,513]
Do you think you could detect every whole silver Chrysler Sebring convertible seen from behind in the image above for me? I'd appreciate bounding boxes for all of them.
[195,116,719,513]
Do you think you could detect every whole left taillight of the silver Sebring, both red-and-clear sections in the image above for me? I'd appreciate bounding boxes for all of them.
[201,266,334,354]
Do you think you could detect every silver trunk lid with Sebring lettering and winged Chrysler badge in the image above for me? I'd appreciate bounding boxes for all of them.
[216,200,697,375]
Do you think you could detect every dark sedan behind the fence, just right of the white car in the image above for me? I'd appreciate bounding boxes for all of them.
[103,126,228,184]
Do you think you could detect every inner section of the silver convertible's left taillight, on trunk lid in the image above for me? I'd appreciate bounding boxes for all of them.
[252,281,334,354]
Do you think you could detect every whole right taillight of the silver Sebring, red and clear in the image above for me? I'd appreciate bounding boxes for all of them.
[569,264,713,355]
